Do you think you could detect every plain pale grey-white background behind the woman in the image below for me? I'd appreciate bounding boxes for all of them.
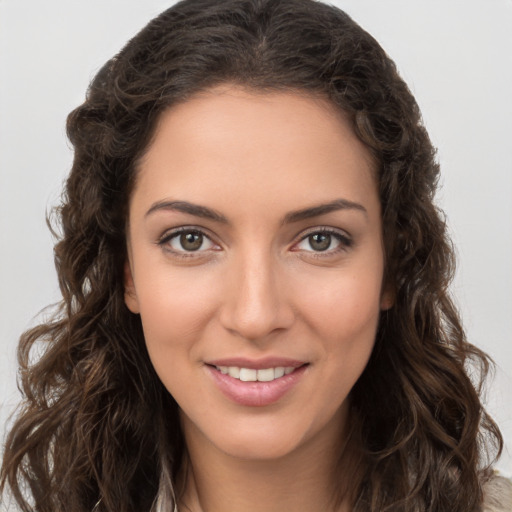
[0,0,512,500]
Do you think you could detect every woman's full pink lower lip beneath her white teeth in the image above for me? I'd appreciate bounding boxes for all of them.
[206,365,307,407]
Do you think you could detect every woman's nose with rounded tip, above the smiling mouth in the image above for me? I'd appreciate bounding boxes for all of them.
[221,251,295,342]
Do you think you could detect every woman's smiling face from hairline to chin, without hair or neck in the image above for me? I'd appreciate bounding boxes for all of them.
[126,86,391,459]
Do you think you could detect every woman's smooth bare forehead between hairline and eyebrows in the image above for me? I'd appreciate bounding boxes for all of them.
[135,85,376,216]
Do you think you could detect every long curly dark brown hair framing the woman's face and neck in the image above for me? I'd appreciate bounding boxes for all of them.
[0,0,502,512]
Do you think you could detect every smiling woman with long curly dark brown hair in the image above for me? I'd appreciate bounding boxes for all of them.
[2,0,507,512]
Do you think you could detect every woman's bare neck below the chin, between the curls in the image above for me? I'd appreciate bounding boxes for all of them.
[179,412,357,512]
